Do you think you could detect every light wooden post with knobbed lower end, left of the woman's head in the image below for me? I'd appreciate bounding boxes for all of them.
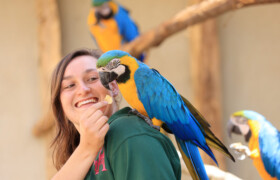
[33,0,61,136]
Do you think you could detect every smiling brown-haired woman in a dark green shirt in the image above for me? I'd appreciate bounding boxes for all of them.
[51,49,181,180]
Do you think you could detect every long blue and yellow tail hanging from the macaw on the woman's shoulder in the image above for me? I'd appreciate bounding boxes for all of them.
[176,138,209,180]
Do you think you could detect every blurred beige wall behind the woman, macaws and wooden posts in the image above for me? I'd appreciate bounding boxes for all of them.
[0,0,280,180]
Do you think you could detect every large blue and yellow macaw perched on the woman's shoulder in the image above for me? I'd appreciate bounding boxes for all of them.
[97,50,234,179]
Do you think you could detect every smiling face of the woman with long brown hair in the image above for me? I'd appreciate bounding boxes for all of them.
[60,56,119,125]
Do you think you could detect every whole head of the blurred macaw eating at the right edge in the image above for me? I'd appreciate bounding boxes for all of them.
[227,110,265,142]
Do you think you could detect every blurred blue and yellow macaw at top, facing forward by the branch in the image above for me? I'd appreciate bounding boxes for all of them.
[88,0,144,61]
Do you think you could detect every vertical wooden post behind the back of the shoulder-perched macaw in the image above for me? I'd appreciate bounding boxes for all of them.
[189,18,226,169]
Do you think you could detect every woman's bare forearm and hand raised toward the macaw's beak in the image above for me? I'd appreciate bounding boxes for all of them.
[52,101,109,180]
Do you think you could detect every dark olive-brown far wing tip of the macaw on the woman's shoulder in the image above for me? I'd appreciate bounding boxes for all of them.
[181,96,235,162]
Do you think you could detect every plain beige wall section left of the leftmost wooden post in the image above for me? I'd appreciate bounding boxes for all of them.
[0,0,45,180]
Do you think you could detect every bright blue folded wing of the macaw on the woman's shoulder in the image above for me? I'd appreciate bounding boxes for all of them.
[134,65,217,177]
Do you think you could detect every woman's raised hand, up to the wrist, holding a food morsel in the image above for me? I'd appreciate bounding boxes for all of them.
[79,101,109,155]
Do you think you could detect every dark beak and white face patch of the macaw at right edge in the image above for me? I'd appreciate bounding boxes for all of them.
[227,118,252,142]
